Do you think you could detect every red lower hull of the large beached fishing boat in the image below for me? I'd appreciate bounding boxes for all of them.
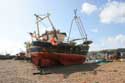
[31,52,86,67]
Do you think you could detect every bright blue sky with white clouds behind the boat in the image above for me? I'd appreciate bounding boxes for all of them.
[0,0,125,54]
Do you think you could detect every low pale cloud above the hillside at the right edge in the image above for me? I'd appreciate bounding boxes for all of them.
[90,34,125,51]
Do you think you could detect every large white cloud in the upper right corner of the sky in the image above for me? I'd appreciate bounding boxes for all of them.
[99,1,125,24]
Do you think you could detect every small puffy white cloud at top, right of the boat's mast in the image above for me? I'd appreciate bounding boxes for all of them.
[81,2,97,15]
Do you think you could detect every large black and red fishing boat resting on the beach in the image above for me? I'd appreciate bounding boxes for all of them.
[28,10,92,67]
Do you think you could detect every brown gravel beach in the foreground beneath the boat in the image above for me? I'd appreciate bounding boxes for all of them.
[0,60,125,83]
